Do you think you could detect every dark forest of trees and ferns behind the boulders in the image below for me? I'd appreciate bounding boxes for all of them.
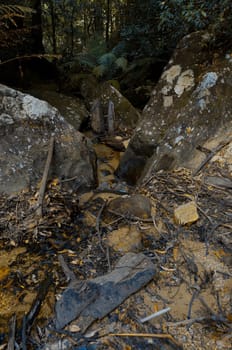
[0,0,232,77]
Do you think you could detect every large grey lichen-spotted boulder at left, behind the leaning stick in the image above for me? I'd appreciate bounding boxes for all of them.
[0,85,96,193]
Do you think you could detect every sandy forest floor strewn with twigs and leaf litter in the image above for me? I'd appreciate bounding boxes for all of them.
[0,138,232,350]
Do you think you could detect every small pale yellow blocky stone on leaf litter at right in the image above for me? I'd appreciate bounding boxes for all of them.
[174,202,199,225]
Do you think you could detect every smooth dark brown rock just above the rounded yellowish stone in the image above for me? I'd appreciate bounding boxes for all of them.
[107,194,151,219]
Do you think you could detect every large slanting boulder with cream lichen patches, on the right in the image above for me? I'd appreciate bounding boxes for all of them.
[117,32,232,184]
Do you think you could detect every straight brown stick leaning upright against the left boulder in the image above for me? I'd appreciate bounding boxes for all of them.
[36,136,55,217]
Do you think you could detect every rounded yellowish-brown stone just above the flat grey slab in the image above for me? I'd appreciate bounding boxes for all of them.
[107,226,142,253]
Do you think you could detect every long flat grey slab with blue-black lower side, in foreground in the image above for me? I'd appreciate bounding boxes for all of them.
[55,253,157,332]
